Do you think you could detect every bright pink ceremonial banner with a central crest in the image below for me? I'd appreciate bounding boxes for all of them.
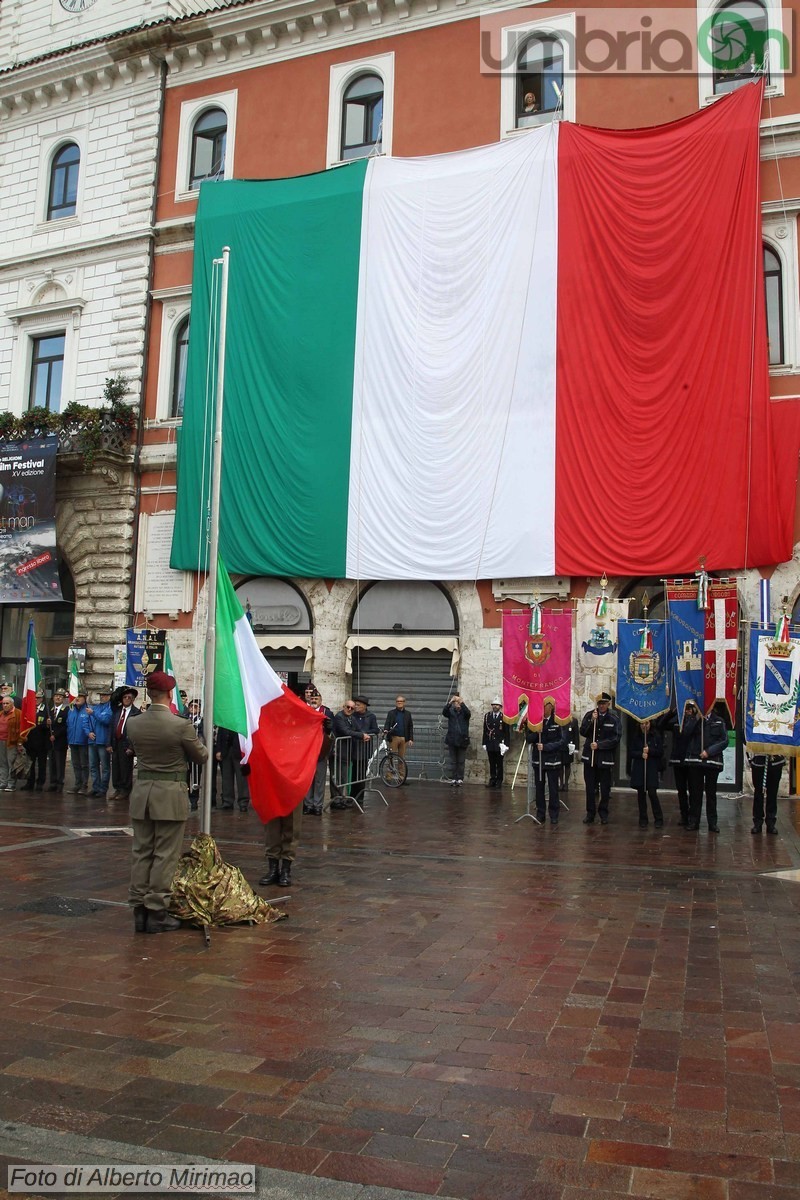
[503,608,572,728]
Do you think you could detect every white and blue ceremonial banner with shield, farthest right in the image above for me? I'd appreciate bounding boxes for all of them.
[745,625,800,756]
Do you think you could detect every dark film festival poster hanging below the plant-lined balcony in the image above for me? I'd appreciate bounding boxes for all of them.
[0,437,62,604]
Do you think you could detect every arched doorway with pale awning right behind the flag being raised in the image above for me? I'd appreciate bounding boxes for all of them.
[235,576,313,695]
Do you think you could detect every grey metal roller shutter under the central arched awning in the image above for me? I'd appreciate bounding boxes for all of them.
[353,649,458,778]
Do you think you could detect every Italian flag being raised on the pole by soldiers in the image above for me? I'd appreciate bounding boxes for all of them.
[213,560,325,822]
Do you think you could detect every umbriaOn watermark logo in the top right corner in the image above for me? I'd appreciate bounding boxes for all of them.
[480,8,794,77]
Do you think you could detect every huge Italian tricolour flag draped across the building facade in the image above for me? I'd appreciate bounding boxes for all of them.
[172,84,796,580]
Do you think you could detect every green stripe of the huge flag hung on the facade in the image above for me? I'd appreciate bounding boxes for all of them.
[172,160,367,577]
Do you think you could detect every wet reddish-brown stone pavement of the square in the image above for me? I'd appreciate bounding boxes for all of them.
[0,784,800,1200]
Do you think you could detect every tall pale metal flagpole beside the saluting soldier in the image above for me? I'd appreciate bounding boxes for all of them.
[200,246,230,833]
